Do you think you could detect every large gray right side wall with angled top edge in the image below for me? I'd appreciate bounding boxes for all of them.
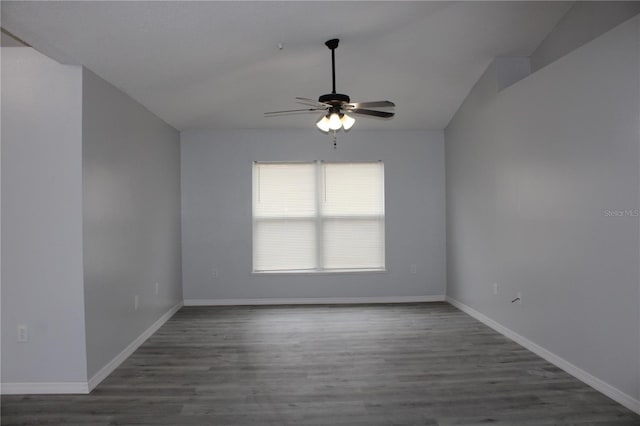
[445,18,640,401]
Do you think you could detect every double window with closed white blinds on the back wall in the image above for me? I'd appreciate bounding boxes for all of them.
[253,162,385,272]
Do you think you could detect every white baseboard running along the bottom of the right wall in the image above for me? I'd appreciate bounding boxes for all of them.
[446,296,640,414]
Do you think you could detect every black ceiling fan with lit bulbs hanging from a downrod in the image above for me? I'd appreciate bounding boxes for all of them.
[264,38,396,136]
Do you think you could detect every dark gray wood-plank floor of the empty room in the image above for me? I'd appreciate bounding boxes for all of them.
[2,303,640,426]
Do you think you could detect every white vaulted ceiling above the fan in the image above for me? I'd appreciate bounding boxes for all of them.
[1,1,571,130]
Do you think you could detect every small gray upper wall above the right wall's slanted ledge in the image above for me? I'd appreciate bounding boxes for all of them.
[531,1,640,71]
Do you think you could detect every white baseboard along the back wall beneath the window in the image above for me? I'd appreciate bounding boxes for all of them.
[184,295,445,306]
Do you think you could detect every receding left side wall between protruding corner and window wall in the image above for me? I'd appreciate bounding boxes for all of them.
[82,69,182,377]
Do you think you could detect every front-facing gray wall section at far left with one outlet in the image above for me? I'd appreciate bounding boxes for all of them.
[1,47,87,384]
